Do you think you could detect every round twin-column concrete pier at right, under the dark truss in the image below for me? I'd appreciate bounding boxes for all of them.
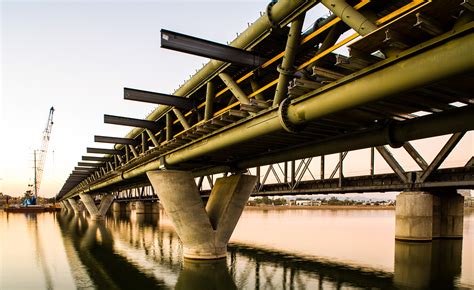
[395,191,464,241]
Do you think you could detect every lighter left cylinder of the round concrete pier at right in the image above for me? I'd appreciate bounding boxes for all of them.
[395,191,433,241]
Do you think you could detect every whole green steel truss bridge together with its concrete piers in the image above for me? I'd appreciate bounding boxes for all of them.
[57,0,474,259]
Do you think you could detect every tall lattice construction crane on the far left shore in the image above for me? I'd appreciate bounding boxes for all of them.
[23,107,54,206]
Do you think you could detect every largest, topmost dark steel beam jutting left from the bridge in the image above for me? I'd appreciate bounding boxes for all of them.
[161,29,266,66]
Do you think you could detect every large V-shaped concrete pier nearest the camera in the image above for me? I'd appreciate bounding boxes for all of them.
[147,170,257,259]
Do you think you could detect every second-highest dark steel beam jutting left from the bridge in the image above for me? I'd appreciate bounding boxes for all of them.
[123,88,194,110]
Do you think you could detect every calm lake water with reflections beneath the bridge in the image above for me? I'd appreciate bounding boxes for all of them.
[0,209,474,289]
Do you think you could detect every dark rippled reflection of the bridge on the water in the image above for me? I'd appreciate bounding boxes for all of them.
[58,214,462,289]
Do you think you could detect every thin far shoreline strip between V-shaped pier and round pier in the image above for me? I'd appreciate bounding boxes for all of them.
[244,205,395,210]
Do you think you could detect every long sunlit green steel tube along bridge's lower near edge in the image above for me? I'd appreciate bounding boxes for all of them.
[60,24,474,201]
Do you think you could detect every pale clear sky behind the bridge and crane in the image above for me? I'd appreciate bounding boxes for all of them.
[0,0,474,197]
